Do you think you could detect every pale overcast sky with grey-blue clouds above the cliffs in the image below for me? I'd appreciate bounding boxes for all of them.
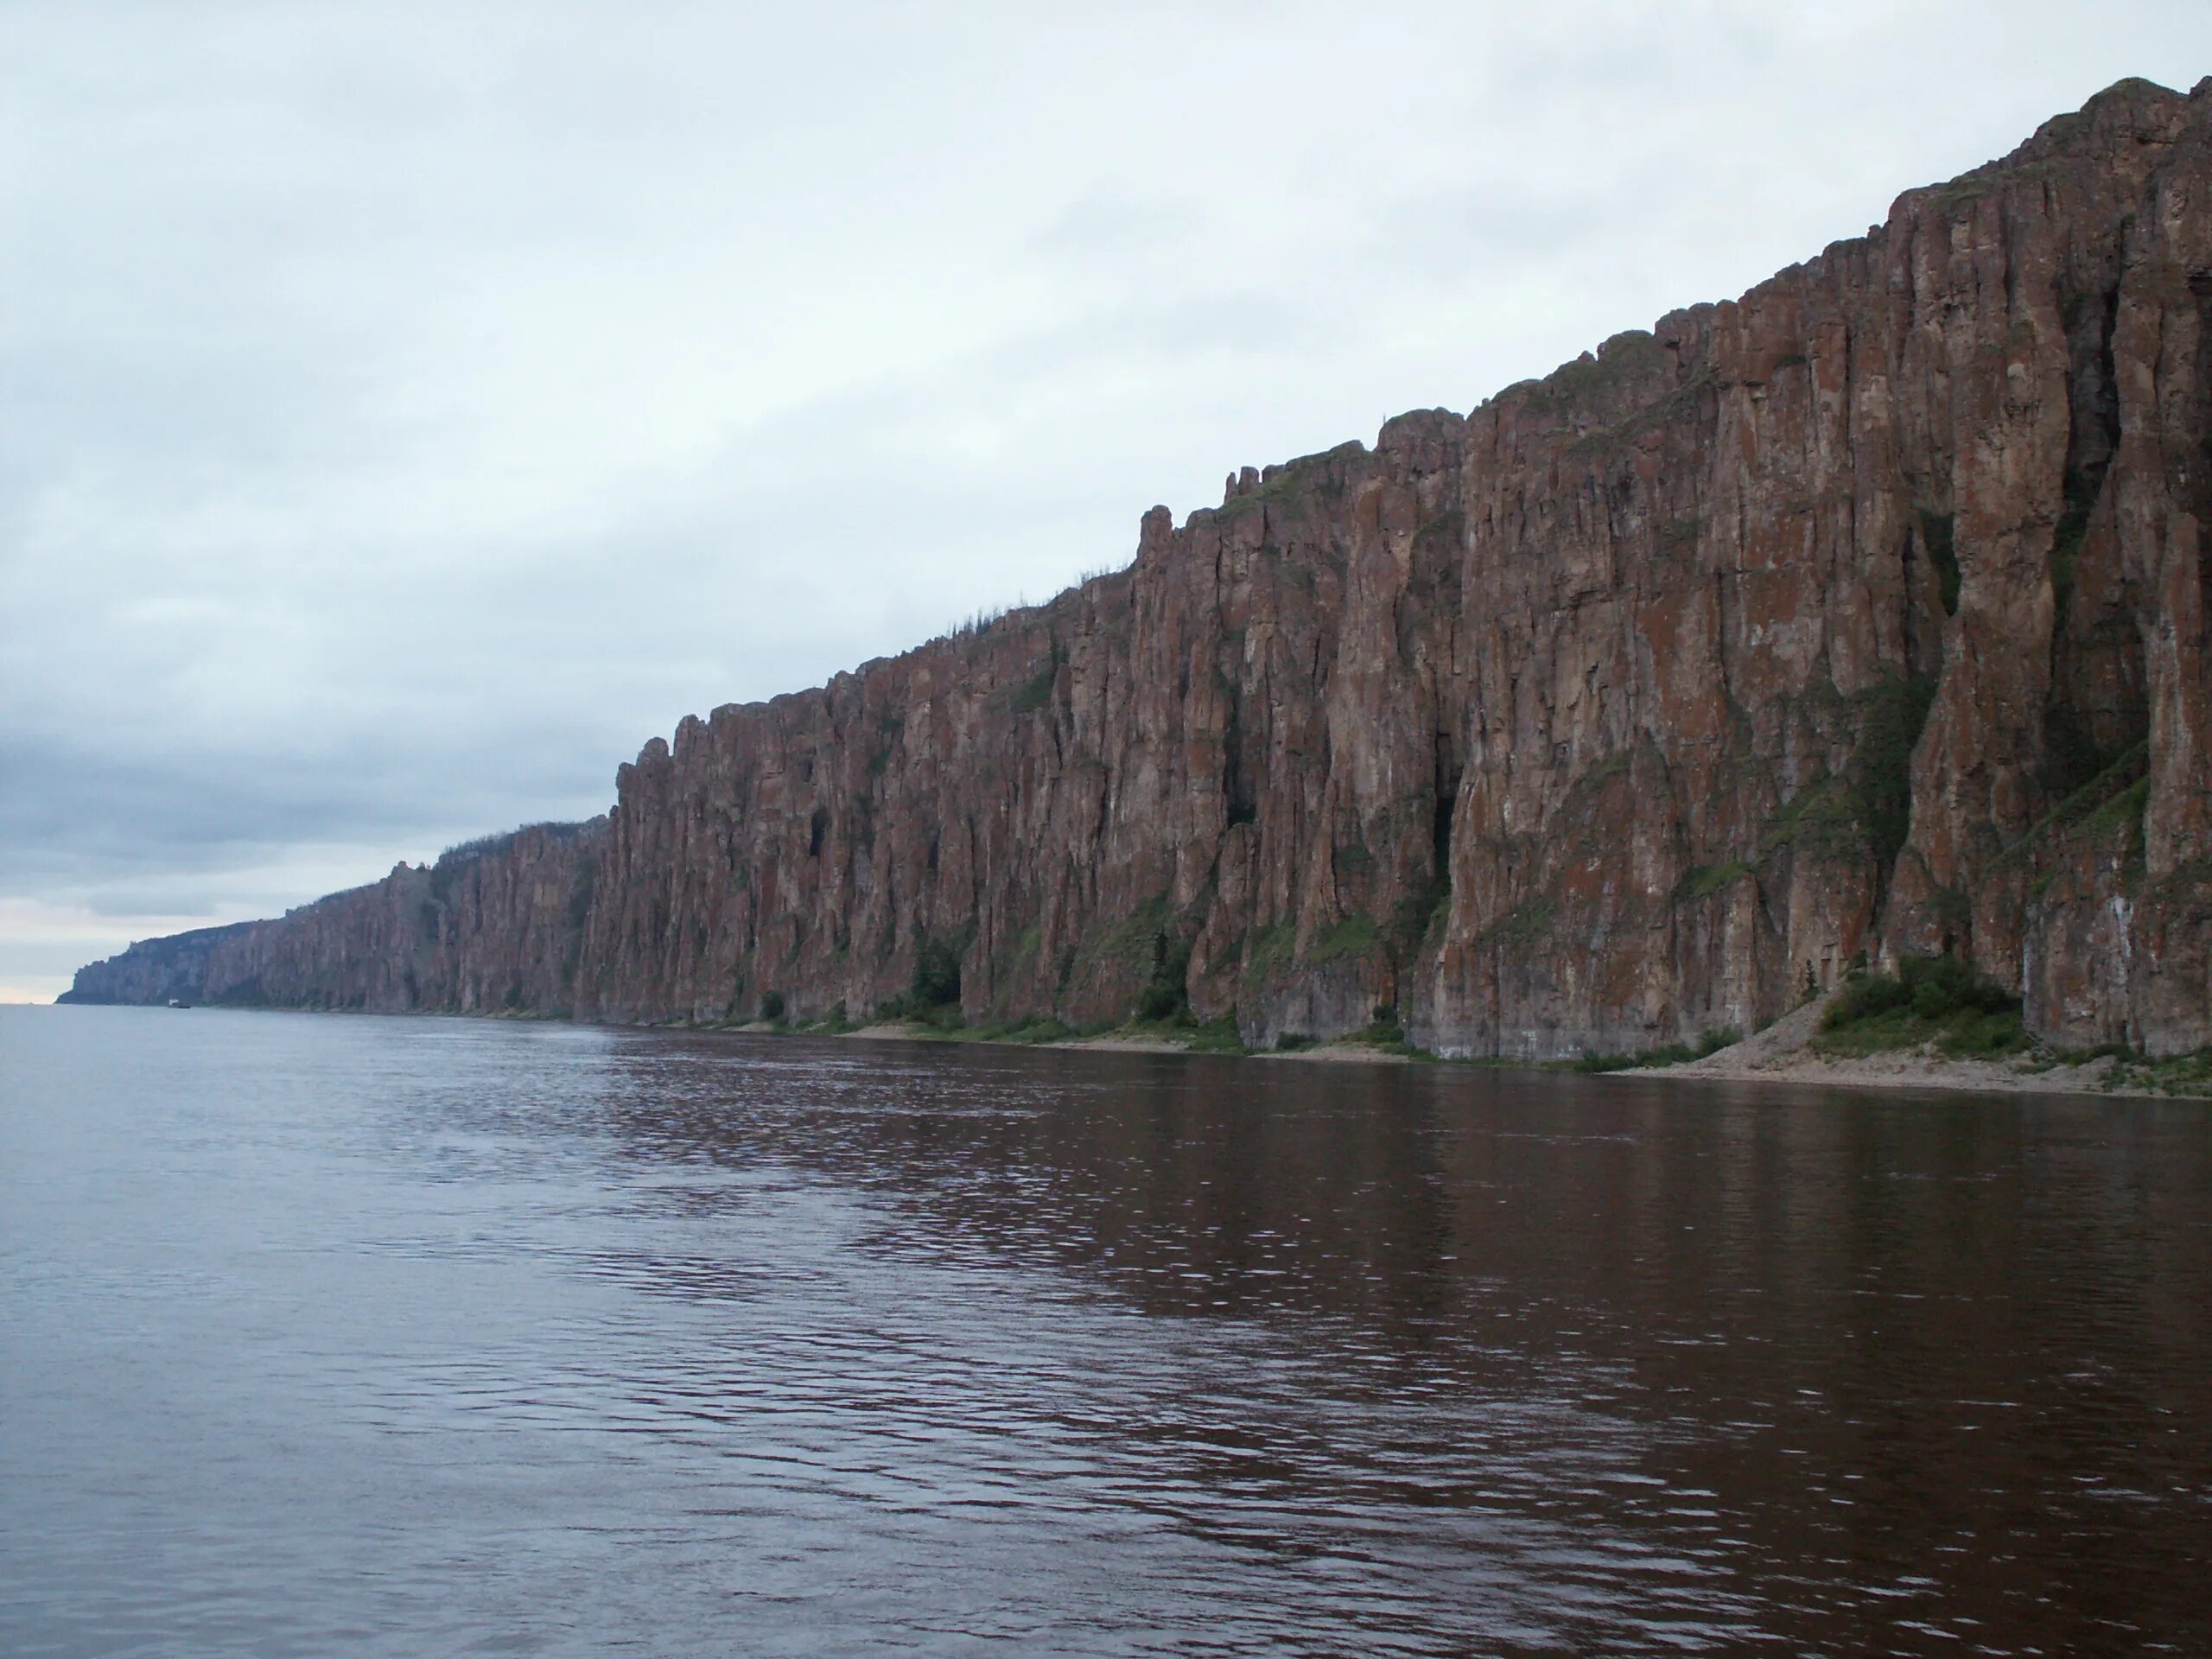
[0,0,2212,1000]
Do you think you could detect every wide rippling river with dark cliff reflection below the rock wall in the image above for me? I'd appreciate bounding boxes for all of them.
[0,1008,2212,1656]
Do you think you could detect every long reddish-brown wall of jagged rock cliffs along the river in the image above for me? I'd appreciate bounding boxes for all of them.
[73,79,2212,1058]
